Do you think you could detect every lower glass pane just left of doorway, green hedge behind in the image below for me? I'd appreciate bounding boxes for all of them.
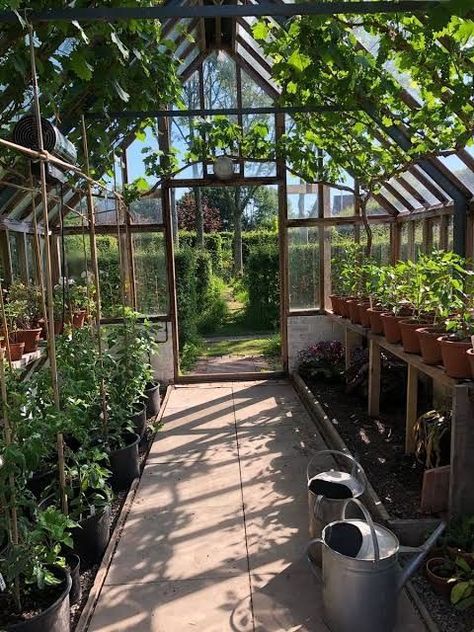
[132,233,169,315]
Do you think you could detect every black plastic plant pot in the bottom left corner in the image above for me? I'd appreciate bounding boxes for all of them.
[5,567,72,632]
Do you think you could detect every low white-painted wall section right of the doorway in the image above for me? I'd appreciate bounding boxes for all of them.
[288,314,343,373]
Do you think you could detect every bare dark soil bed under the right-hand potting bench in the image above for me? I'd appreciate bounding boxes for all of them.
[306,380,423,518]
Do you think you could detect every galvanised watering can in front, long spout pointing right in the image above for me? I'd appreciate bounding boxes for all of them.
[308,499,446,632]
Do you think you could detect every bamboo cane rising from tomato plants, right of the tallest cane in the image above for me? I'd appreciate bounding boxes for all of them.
[82,115,108,440]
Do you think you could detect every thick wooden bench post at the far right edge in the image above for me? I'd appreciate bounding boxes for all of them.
[449,384,474,515]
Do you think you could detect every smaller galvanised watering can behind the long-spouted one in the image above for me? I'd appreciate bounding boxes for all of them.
[306,450,367,566]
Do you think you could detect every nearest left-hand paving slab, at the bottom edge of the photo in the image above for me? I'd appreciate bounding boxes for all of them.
[89,574,253,632]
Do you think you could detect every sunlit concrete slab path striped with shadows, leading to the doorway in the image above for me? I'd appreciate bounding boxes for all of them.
[89,381,425,632]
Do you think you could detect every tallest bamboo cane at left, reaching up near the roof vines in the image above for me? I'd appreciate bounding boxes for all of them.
[29,24,68,515]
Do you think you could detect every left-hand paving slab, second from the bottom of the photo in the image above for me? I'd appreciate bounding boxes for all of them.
[106,505,248,584]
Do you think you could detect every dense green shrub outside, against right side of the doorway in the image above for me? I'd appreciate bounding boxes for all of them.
[244,245,280,330]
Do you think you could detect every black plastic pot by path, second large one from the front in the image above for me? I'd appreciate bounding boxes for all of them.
[72,506,110,570]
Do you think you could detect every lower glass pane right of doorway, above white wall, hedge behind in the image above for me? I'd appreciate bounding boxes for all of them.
[288,228,321,310]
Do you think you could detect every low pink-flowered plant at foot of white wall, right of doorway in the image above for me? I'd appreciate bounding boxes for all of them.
[298,340,344,380]
